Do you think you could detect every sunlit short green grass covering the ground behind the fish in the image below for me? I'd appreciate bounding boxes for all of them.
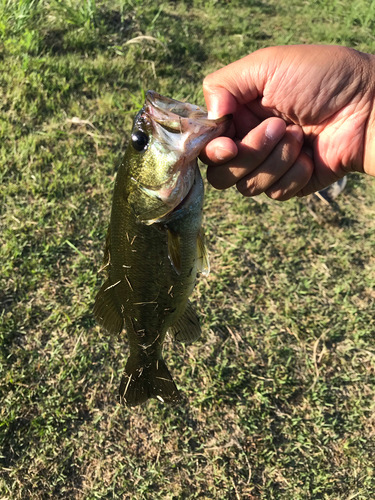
[0,0,375,500]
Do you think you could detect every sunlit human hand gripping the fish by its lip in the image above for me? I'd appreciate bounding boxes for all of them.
[201,45,375,200]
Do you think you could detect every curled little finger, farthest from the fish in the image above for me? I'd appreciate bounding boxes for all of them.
[265,153,314,201]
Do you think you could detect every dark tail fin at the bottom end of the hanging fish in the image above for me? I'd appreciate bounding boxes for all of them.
[119,357,181,406]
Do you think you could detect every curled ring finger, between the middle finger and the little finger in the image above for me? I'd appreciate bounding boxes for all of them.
[237,125,303,196]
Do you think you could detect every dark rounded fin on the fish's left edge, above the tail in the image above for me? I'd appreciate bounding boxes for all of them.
[94,279,124,335]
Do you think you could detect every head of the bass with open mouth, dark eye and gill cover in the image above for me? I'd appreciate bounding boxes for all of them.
[126,91,229,224]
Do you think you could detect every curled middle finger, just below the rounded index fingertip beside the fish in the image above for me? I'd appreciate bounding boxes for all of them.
[207,118,286,189]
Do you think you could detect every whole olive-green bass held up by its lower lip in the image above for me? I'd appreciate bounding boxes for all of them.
[93,90,230,407]
